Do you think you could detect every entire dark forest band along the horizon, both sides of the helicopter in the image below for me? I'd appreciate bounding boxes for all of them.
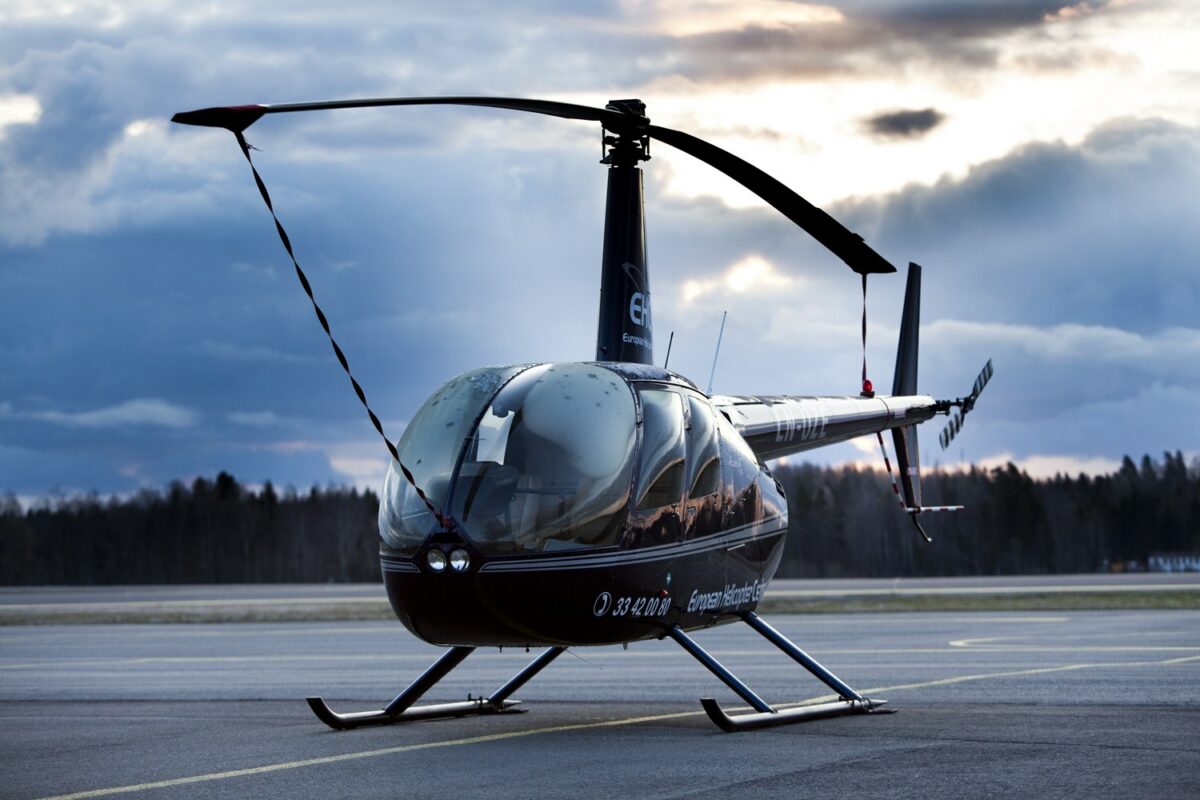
[0,452,1200,585]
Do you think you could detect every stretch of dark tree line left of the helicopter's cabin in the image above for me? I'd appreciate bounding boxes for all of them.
[0,473,379,585]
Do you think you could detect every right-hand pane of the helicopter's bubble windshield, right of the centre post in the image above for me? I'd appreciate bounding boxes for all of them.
[450,363,636,555]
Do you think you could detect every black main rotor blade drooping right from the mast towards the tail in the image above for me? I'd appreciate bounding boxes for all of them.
[647,125,896,275]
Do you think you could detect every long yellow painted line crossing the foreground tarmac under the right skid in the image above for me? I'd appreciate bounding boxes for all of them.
[28,656,1200,800]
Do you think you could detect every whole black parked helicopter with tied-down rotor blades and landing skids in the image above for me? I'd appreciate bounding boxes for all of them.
[172,97,991,732]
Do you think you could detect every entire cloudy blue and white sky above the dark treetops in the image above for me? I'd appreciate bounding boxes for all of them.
[0,0,1200,498]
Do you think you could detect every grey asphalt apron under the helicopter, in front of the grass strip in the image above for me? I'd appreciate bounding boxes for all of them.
[0,610,1200,800]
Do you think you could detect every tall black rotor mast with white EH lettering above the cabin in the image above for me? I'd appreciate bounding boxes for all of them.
[596,100,654,363]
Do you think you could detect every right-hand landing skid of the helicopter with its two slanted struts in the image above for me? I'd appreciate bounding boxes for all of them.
[667,612,887,733]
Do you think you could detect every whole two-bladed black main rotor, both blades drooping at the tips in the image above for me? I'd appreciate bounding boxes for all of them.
[170,97,896,275]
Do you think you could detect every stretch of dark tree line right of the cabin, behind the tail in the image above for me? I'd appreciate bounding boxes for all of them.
[775,452,1200,577]
